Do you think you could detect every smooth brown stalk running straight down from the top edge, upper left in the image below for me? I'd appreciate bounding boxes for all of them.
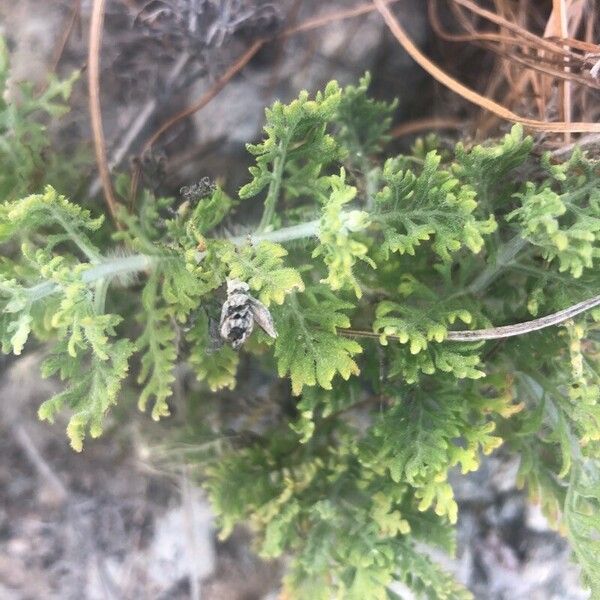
[88,0,119,227]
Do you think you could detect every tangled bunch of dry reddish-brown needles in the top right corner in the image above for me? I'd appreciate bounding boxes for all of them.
[428,0,600,138]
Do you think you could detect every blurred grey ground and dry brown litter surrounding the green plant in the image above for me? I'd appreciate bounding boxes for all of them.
[0,0,600,600]
